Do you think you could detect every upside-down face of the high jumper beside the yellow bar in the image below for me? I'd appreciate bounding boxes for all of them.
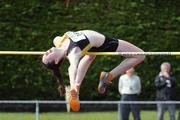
[42,47,60,64]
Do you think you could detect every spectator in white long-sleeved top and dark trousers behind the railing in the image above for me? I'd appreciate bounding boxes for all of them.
[119,68,141,120]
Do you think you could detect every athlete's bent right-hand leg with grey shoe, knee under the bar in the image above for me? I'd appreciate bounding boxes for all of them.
[98,40,145,94]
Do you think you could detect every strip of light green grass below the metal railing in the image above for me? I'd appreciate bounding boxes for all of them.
[0,111,177,120]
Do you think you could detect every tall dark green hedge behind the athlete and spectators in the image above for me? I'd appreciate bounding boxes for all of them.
[0,0,180,119]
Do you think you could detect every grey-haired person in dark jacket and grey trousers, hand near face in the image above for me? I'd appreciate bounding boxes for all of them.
[155,62,176,120]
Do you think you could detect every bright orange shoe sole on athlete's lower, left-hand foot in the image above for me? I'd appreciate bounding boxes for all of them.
[69,89,80,112]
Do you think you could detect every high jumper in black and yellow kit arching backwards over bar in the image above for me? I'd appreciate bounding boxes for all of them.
[42,30,145,111]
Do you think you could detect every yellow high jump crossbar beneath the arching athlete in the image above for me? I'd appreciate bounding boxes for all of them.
[0,51,180,56]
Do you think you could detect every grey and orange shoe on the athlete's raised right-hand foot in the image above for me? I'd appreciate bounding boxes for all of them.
[98,72,112,94]
